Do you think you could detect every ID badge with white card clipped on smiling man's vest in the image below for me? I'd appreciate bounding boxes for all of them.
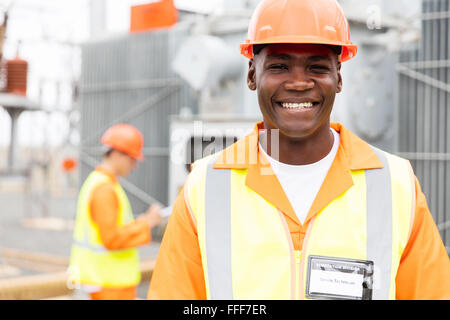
[306,256,373,300]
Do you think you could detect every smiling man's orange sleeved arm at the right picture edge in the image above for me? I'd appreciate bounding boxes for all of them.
[396,178,450,300]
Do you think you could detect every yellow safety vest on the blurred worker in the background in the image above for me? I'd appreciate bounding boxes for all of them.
[69,170,141,288]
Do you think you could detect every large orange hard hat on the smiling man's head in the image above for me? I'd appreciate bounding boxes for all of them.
[241,0,358,62]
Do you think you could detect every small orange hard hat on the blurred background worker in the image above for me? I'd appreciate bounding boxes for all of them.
[100,123,144,161]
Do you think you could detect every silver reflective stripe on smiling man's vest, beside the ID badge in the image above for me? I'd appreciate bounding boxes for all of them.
[365,146,392,300]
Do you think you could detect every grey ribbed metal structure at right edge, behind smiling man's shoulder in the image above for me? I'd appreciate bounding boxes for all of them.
[396,0,450,250]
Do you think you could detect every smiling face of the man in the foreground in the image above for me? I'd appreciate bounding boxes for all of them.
[247,44,342,140]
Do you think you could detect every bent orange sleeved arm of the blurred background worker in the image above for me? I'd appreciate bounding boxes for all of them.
[90,183,151,250]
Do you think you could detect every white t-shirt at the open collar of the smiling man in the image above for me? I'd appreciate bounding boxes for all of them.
[259,129,340,224]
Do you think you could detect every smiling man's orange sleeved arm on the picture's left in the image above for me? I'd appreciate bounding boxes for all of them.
[148,191,206,300]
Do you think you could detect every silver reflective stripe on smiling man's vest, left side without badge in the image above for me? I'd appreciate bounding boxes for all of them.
[205,157,233,300]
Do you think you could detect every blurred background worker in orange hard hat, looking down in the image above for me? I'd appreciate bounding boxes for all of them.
[70,124,161,300]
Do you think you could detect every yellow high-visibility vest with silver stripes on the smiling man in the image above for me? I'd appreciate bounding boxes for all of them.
[185,147,415,300]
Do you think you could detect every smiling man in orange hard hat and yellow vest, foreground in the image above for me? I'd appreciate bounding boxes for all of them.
[148,0,450,300]
